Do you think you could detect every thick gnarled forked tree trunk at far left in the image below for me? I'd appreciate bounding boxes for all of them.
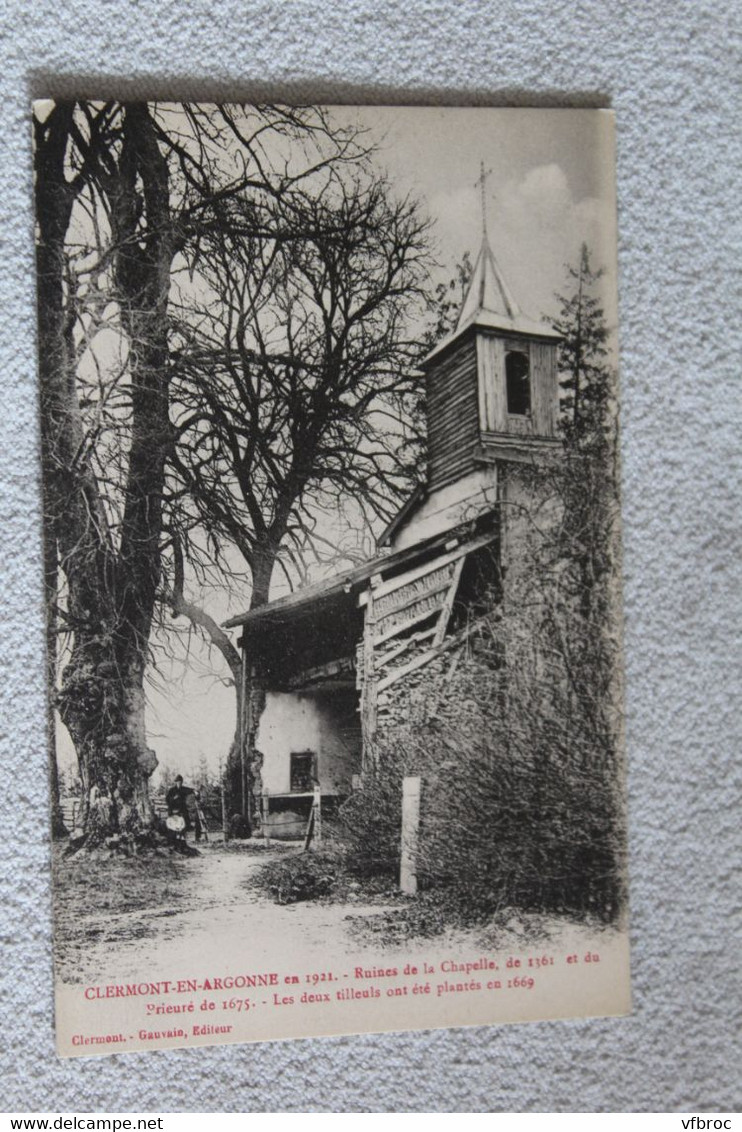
[36,104,173,846]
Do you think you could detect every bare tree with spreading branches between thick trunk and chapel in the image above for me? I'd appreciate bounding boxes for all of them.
[161,161,427,815]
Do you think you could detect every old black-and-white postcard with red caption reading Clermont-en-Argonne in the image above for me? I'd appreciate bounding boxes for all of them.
[34,102,630,1056]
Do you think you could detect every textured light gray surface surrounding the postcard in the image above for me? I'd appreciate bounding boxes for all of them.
[0,0,742,1112]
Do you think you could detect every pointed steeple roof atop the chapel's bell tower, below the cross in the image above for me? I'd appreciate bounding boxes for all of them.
[423,229,560,365]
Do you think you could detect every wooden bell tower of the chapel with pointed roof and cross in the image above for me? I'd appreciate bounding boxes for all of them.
[378,169,561,550]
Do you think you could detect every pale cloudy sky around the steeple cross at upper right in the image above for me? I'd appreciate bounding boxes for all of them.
[334,106,615,325]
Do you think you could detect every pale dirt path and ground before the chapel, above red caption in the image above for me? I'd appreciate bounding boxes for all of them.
[56,842,620,1000]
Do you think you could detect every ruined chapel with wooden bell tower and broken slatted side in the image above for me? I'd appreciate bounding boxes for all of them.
[227,227,561,835]
